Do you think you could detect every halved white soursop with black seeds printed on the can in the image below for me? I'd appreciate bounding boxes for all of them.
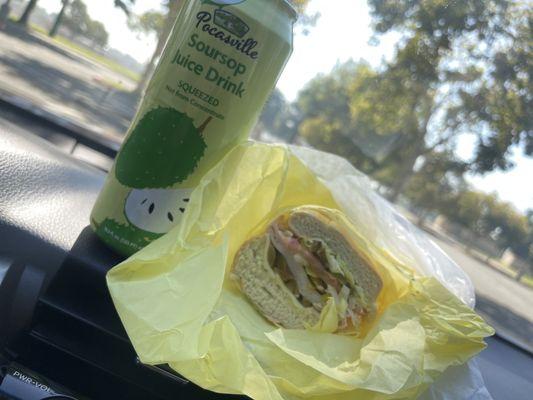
[124,189,192,234]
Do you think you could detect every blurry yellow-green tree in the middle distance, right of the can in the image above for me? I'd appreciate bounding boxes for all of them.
[296,61,400,174]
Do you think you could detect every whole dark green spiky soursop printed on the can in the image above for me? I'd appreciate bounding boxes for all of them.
[115,107,206,189]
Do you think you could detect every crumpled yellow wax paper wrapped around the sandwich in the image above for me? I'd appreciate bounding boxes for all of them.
[107,143,493,400]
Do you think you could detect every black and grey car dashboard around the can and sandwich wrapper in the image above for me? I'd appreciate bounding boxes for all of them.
[0,0,533,400]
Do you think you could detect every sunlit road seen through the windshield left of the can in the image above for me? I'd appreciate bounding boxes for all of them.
[0,24,137,139]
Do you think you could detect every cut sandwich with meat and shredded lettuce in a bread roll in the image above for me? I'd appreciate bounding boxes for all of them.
[231,206,383,334]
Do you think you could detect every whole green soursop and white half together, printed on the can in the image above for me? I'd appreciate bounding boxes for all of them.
[115,107,211,235]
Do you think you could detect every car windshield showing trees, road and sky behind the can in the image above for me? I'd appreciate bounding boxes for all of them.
[0,0,533,351]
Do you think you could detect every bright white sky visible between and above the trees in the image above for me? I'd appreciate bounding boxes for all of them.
[39,0,533,211]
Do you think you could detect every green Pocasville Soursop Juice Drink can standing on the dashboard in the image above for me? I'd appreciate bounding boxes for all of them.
[91,0,296,255]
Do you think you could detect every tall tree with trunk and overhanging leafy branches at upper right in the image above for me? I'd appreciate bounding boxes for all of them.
[369,0,533,199]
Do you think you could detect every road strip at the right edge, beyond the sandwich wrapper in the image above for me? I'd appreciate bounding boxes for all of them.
[432,236,533,352]
